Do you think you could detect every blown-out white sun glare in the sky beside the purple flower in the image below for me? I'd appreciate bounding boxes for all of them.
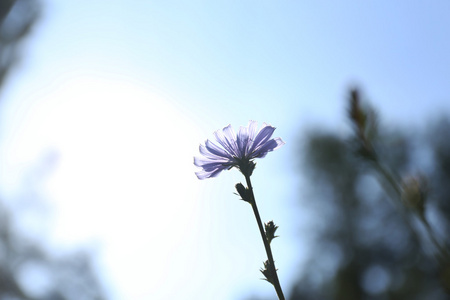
[18,78,202,299]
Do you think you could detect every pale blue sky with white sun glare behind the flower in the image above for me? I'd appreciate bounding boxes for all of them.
[0,0,450,300]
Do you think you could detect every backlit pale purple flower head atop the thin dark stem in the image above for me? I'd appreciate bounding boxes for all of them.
[194,121,284,179]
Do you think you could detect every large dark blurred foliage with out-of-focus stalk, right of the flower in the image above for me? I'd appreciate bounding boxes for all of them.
[246,90,450,300]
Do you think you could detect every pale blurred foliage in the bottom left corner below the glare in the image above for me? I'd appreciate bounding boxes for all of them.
[0,200,104,300]
